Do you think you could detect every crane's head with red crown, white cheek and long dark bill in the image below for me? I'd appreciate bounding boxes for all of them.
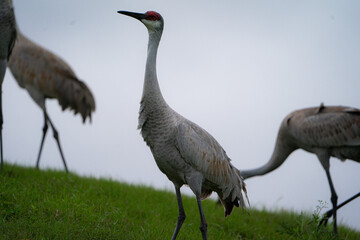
[118,11,164,32]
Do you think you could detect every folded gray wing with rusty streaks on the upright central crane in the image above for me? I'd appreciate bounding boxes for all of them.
[176,120,246,206]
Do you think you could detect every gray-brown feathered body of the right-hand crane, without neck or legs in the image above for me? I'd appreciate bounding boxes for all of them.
[281,105,360,161]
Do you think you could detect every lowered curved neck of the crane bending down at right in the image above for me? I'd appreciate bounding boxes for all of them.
[241,136,296,179]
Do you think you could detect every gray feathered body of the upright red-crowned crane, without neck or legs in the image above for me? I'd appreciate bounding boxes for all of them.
[139,97,246,215]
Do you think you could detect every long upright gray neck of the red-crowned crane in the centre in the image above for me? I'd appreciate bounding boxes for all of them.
[142,31,165,103]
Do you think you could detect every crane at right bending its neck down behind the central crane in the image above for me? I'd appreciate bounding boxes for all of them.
[242,104,360,233]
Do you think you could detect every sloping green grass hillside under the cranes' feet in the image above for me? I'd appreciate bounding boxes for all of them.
[0,164,360,240]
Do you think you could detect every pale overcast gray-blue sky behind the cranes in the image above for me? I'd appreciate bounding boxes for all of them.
[3,0,360,230]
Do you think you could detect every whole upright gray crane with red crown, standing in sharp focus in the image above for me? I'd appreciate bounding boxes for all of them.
[118,11,246,239]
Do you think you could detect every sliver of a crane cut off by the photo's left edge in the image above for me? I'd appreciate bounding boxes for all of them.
[0,0,16,171]
